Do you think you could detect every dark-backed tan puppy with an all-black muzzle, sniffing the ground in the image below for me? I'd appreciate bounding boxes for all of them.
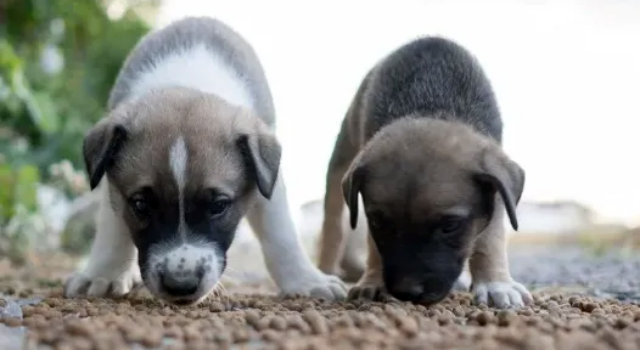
[319,37,532,308]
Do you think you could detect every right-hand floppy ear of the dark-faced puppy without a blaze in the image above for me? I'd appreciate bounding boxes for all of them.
[475,148,525,231]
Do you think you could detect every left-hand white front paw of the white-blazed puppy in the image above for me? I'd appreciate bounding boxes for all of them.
[64,266,142,298]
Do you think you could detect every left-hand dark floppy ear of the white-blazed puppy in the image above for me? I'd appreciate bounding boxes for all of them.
[82,118,127,190]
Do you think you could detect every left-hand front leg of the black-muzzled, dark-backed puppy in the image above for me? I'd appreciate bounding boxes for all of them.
[348,235,393,302]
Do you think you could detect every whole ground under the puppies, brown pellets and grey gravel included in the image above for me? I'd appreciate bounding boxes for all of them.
[0,245,640,350]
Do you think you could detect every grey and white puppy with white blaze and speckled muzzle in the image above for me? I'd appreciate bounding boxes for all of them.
[65,18,346,304]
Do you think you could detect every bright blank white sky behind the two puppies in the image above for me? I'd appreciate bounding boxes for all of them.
[148,0,640,225]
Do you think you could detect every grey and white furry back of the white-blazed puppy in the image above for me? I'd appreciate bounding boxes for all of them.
[107,17,275,125]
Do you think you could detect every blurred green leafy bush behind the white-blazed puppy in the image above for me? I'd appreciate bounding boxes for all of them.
[0,0,157,262]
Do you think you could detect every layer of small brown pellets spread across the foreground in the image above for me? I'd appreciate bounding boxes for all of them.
[2,293,640,350]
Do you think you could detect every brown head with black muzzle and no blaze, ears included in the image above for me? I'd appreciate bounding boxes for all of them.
[342,118,525,304]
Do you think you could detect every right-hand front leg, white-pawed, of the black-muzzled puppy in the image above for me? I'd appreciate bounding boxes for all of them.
[469,200,533,309]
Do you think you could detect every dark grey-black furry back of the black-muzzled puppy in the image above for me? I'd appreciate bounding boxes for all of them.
[359,37,502,142]
